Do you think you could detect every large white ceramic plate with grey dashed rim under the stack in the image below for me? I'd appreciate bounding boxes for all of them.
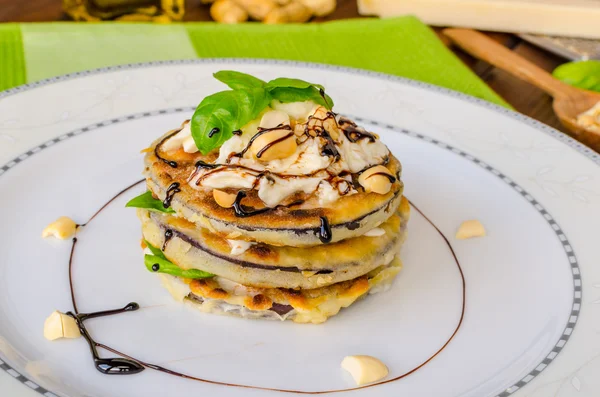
[0,60,600,397]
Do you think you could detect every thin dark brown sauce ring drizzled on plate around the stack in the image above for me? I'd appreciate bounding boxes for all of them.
[67,180,466,395]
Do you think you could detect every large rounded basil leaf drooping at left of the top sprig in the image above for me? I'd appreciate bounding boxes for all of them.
[191,88,269,154]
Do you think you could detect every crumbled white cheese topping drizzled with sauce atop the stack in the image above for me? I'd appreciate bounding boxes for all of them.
[186,101,389,207]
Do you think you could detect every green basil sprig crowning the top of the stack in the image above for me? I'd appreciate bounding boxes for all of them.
[191,70,333,154]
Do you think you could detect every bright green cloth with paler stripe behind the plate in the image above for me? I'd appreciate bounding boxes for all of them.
[0,16,507,106]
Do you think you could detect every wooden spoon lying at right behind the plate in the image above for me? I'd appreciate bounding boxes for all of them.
[443,28,600,152]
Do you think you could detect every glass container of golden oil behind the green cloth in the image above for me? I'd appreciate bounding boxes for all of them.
[63,0,185,23]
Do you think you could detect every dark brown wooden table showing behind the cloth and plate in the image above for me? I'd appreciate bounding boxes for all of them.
[0,0,566,131]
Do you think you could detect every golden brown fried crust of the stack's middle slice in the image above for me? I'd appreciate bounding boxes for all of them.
[139,199,410,278]
